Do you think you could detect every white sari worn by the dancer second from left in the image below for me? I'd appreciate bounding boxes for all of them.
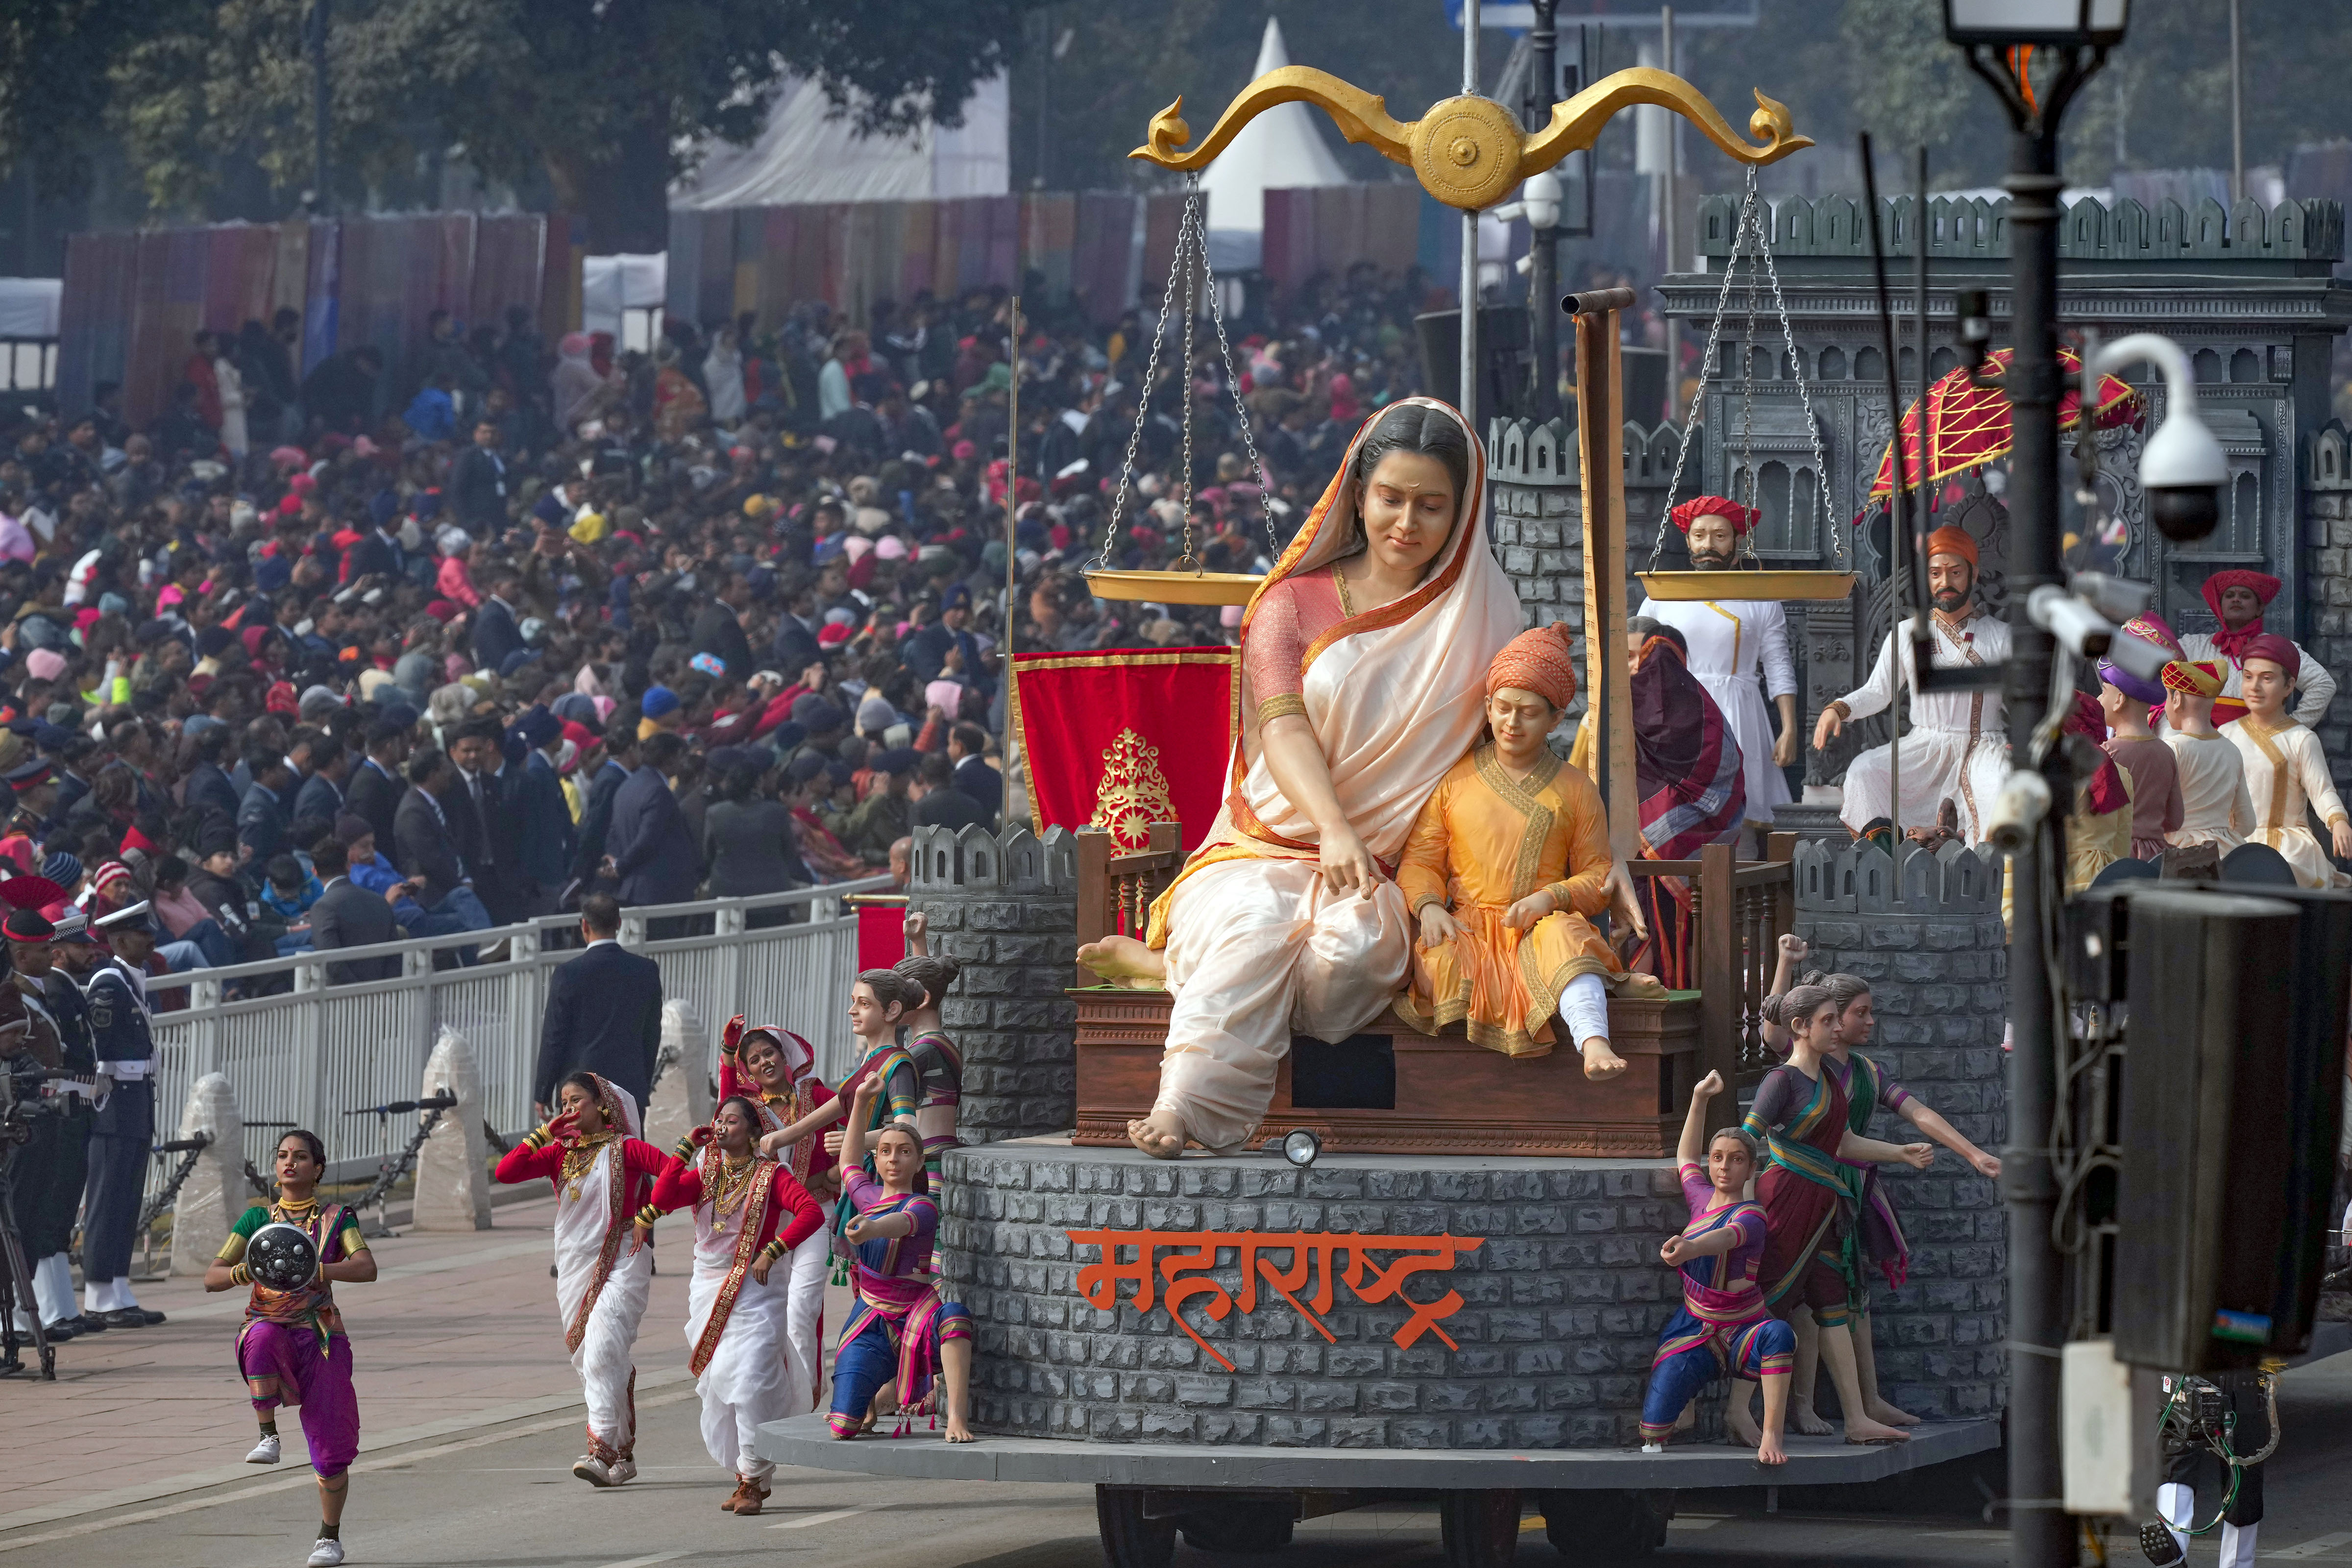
[555,1075,654,1465]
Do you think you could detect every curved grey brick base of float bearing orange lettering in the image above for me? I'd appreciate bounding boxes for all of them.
[943,1138,1722,1448]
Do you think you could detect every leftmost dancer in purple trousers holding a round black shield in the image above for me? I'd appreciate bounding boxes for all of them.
[205,1128,376,1568]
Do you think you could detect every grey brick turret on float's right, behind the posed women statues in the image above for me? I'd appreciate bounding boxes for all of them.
[1797,844,2009,1420]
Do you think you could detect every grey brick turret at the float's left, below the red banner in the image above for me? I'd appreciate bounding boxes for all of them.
[908,828,1077,1143]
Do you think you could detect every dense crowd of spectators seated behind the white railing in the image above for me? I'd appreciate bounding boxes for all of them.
[0,268,1425,980]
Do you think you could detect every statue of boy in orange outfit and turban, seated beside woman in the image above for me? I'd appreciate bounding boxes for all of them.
[1397,625,1663,1079]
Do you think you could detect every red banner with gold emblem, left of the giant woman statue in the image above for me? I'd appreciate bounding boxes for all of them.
[1014,649,1232,851]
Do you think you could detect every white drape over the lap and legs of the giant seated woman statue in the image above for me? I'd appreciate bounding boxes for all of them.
[1159,860,1414,1150]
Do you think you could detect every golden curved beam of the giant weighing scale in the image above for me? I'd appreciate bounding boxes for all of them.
[1129,66,1813,212]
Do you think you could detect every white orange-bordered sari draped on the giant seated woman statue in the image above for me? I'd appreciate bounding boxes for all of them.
[1148,397,1519,1150]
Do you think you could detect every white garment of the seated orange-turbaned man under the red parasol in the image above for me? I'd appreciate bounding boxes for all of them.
[1839,611,2009,844]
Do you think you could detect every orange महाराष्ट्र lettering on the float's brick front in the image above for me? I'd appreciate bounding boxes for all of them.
[1063,1229,1479,1373]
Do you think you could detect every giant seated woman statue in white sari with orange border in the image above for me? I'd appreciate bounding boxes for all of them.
[1079,397,1519,1159]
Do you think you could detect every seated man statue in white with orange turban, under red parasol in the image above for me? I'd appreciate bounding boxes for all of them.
[1813,529,2009,844]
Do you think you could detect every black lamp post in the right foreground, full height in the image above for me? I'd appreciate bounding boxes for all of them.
[1947,24,2107,1568]
